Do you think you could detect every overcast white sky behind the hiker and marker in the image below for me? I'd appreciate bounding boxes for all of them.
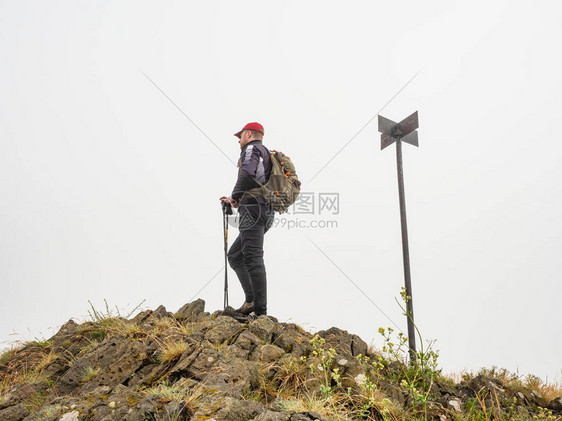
[0,0,562,379]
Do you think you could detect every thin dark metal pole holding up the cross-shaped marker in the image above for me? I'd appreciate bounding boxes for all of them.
[396,138,416,364]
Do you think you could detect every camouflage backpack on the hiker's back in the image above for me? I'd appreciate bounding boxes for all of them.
[248,149,301,213]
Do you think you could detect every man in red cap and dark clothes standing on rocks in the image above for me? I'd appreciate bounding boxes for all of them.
[220,122,274,316]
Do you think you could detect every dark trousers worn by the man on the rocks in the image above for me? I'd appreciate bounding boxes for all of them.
[228,204,274,315]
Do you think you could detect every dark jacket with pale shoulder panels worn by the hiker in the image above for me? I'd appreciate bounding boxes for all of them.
[231,140,271,203]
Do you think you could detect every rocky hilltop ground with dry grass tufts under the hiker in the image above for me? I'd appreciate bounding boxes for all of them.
[0,300,562,421]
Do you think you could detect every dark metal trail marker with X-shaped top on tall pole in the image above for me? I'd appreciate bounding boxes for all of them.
[379,111,419,364]
